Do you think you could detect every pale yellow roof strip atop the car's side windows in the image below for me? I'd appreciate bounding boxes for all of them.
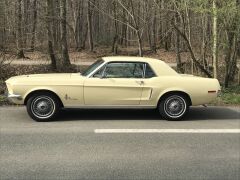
[102,56,163,62]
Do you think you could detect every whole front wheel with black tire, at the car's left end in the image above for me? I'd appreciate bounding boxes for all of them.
[27,92,61,122]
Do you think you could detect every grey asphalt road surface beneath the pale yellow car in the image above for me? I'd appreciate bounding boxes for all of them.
[0,107,240,180]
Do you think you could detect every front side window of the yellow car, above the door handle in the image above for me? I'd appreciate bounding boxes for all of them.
[104,62,143,78]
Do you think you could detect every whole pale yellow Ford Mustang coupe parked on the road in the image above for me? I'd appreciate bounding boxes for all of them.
[6,56,220,121]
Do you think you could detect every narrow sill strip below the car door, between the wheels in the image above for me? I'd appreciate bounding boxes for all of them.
[64,105,156,109]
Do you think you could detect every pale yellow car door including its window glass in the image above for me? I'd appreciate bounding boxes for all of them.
[84,62,144,106]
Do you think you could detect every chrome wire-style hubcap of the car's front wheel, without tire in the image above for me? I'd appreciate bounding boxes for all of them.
[31,96,55,118]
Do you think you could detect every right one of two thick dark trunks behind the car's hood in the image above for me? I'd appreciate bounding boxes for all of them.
[59,0,70,69]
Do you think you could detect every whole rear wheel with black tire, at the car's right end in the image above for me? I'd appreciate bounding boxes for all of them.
[158,94,189,121]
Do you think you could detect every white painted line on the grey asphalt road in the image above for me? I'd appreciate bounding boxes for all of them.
[94,129,240,134]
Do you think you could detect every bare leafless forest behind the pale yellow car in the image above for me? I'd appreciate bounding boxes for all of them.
[0,0,240,105]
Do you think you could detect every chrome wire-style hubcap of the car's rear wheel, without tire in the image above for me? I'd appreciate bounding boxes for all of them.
[164,95,186,118]
